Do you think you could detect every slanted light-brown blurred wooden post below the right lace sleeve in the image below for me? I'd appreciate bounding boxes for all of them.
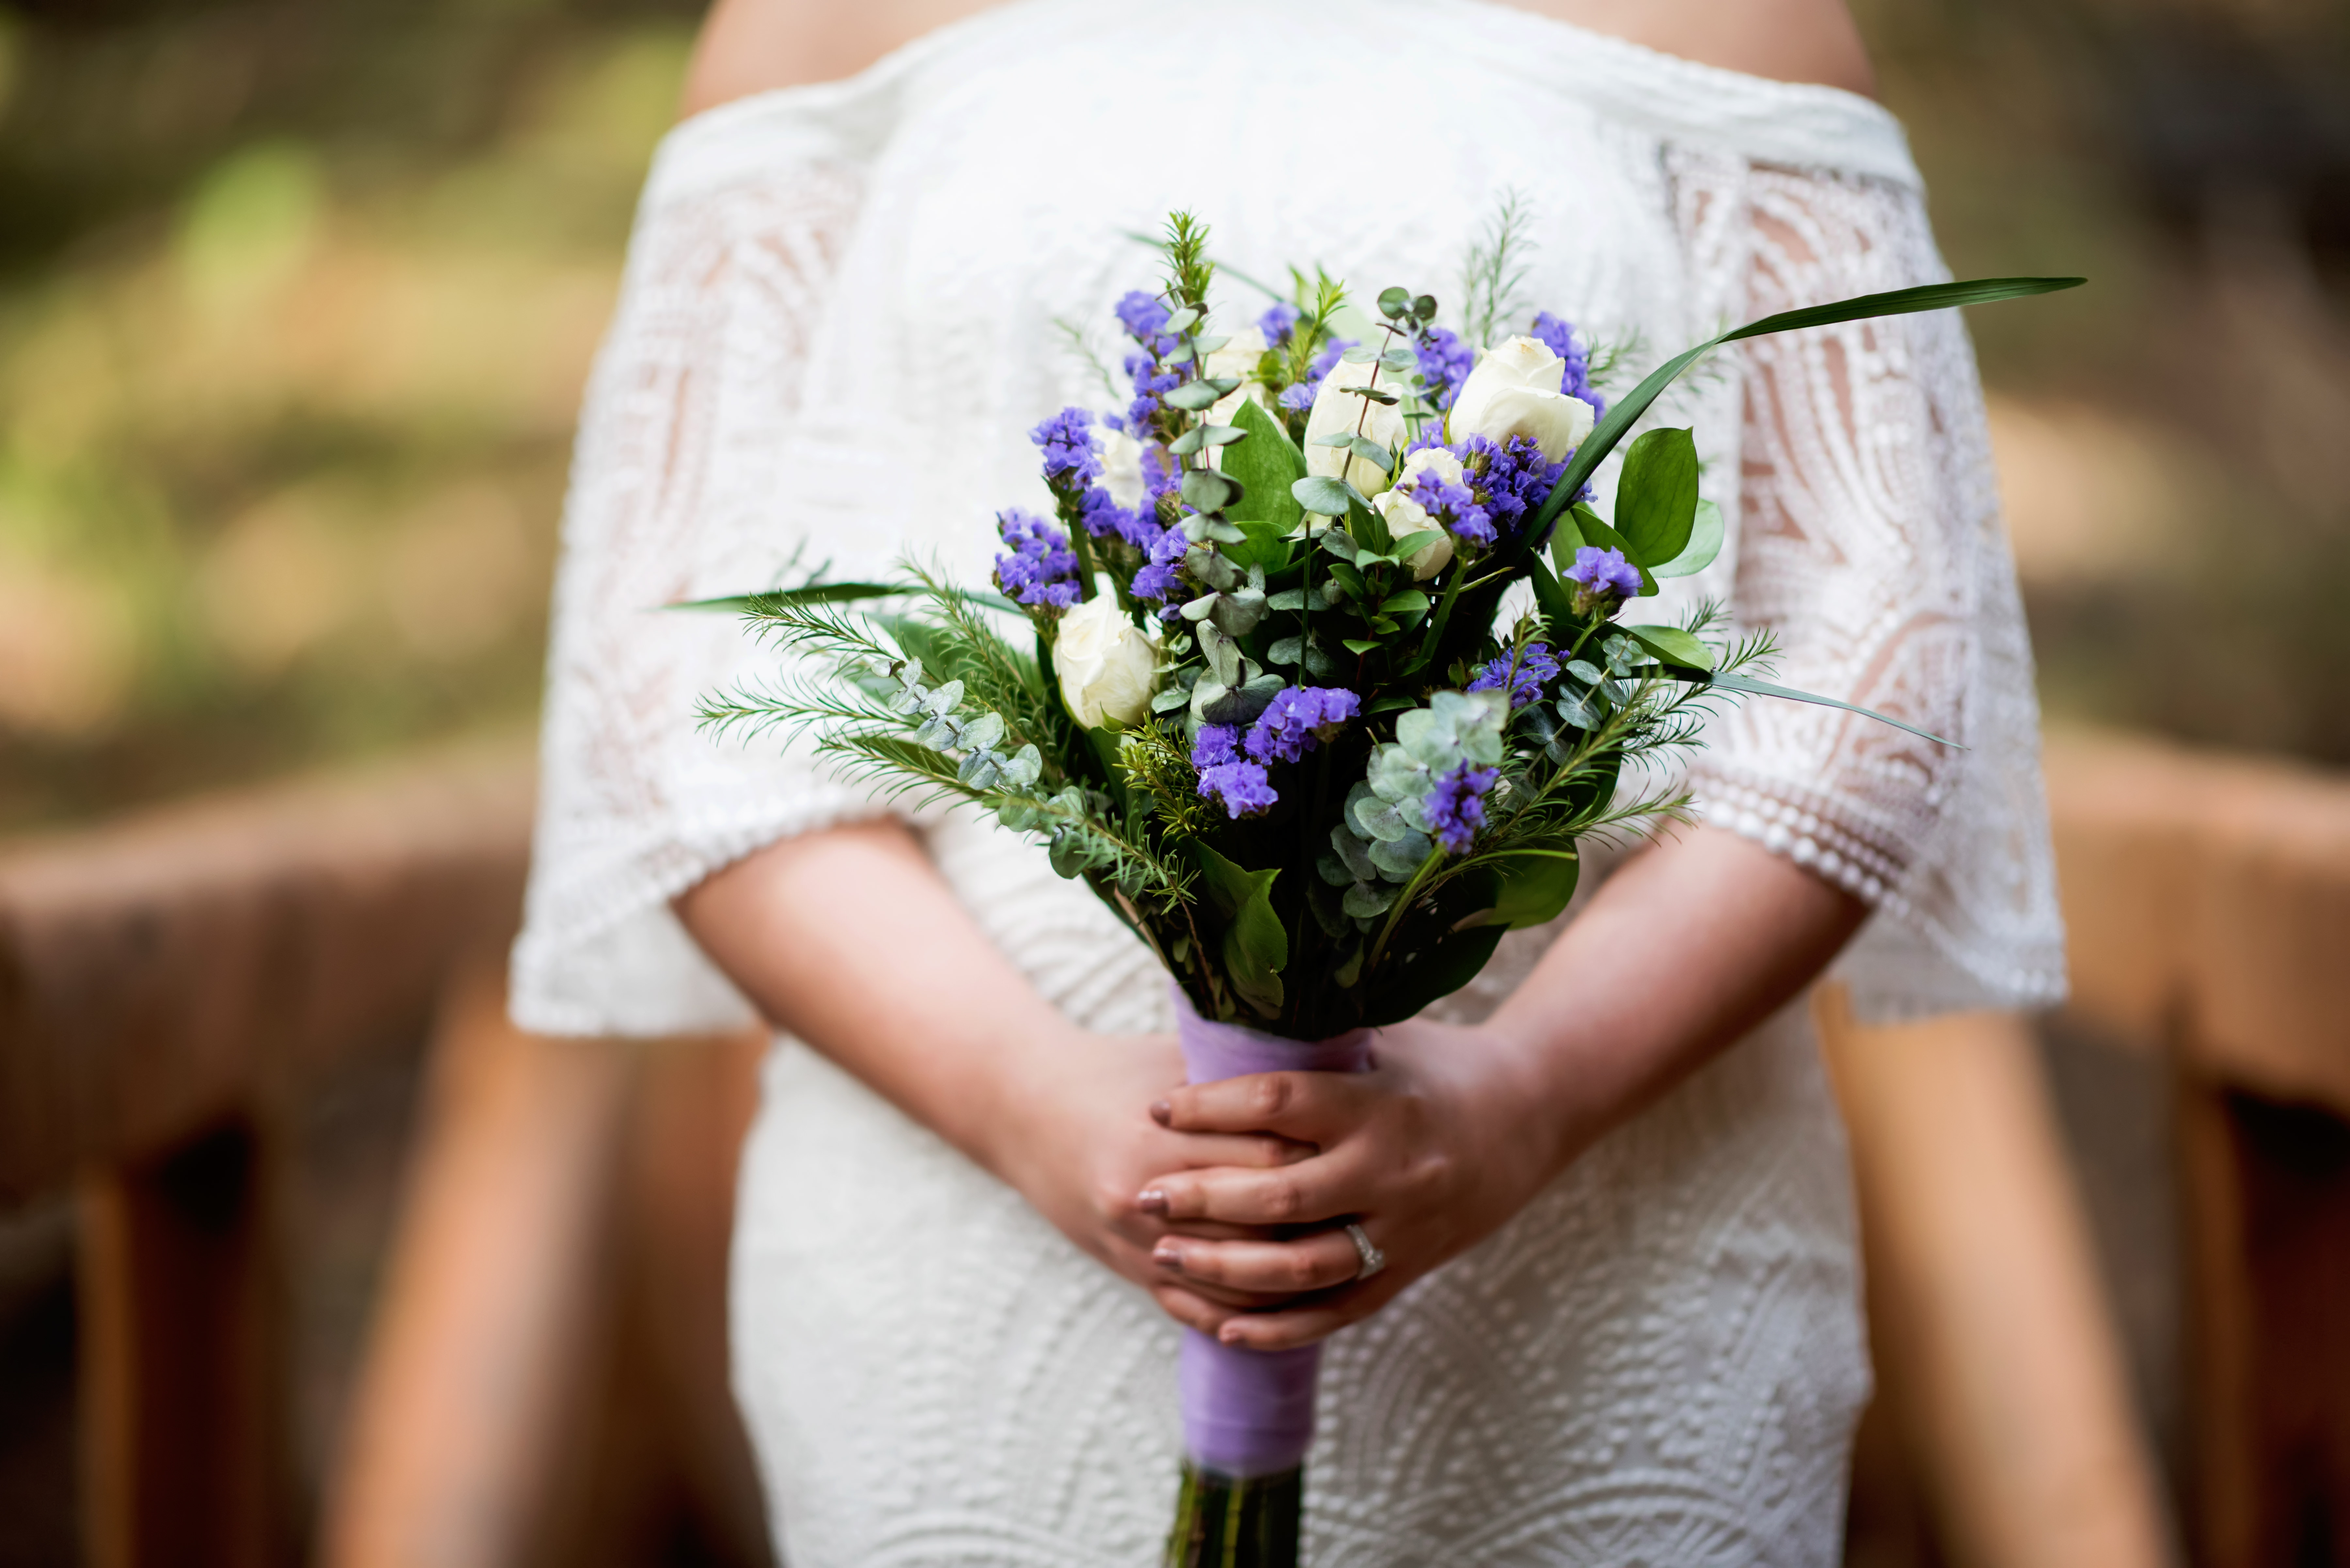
[1817,987,2169,1568]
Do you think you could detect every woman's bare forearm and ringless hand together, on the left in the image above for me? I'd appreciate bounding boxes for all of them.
[677,820,1304,1312]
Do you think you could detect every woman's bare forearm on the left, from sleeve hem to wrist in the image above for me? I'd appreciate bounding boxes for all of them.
[677,820,1069,1175]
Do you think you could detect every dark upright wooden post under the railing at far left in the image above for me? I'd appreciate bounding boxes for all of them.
[80,1124,296,1568]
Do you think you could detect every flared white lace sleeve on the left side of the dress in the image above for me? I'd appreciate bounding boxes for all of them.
[512,158,881,1034]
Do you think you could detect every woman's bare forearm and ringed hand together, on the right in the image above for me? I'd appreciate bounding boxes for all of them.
[1140,828,1868,1349]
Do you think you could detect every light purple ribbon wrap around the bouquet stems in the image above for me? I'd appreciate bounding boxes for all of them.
[1175,987,1372,1479]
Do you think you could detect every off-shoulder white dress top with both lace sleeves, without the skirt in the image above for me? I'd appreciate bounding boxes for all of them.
[517,0,2061,1032]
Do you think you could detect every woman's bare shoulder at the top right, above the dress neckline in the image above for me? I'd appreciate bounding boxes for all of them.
[1502,0,1878,96]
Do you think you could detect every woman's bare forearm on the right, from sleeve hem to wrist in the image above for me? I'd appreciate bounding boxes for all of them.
[1490,828,1868,1185]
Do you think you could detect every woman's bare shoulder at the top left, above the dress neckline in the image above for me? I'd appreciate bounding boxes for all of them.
[682,0,994,115]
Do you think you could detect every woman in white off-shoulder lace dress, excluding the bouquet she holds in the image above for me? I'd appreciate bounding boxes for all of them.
[515,0,2063,1568]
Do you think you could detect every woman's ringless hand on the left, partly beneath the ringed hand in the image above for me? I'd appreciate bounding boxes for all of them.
[985,1025,1314,1321]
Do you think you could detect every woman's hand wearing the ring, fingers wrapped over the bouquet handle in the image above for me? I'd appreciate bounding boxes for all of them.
[1137,1020,1574,1349]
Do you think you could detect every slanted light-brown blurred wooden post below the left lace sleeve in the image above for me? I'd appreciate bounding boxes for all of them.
[322,971,637,1568]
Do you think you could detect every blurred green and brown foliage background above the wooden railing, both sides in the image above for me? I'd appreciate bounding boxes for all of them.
[0,0,2350,830]
